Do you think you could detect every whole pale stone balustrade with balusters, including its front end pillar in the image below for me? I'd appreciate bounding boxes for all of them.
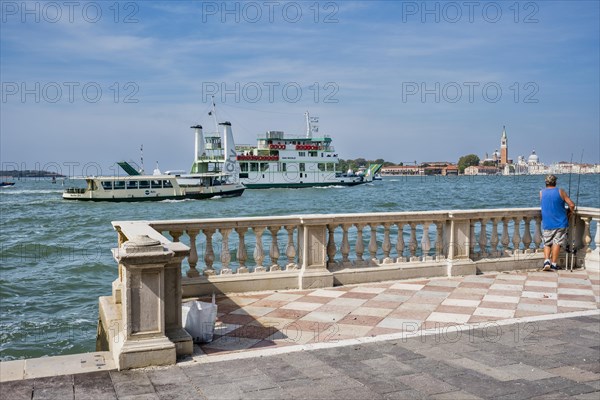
[98,208,600,369]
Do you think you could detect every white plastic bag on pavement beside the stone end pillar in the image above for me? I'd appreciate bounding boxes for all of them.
[181,293,217,343]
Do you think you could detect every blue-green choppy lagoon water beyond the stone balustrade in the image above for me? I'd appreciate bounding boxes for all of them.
[0,175,600,360]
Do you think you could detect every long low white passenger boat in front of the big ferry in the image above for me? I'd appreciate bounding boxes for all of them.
[63,173,245,202]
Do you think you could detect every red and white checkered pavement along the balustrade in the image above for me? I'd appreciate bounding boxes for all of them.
[195,270,600,356]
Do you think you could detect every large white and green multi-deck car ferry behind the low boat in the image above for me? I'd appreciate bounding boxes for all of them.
[192,109,377,189]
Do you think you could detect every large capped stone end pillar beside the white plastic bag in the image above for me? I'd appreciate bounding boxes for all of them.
[113,235,176,370]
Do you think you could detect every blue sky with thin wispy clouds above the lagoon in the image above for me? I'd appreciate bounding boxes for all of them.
[0,0,600,175]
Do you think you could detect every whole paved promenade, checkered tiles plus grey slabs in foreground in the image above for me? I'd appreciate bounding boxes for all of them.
[0,269,600,399]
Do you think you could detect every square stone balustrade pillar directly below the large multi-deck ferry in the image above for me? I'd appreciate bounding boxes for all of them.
[298,224,333,289]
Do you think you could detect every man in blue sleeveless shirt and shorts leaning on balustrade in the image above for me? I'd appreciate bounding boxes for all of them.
[540,175,575,271]
